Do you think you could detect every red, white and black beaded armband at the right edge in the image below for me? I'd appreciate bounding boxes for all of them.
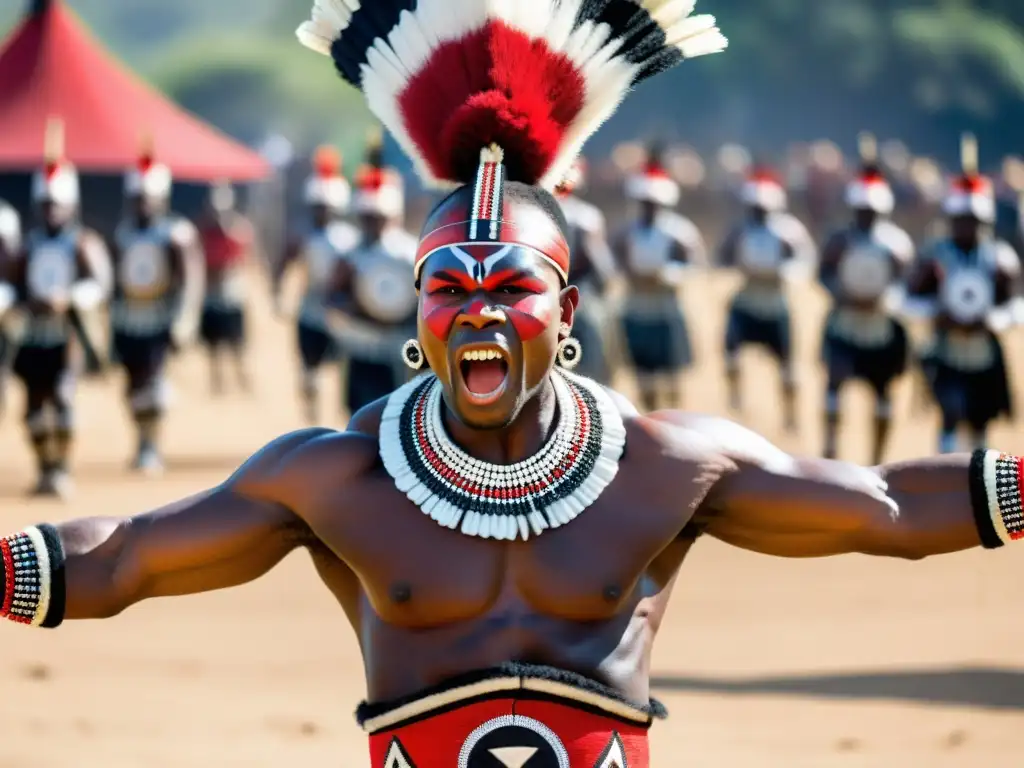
[970,451,1024,549]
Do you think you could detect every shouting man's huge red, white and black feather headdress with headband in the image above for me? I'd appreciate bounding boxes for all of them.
[298,0,726,284]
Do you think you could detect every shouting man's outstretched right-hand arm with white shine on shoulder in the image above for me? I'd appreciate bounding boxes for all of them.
[653,414,999,559]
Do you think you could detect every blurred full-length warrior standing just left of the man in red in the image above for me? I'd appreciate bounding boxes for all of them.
[111,141,204,474]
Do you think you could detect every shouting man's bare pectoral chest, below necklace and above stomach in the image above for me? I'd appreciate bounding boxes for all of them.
[315,450,688,628]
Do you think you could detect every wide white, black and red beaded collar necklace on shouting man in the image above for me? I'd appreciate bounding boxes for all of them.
[380,369,626,541]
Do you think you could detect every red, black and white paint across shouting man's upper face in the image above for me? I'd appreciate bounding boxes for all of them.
[422,244,558,341]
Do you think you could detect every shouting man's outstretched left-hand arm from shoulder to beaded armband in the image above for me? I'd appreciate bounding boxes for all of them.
[0,429,330,626]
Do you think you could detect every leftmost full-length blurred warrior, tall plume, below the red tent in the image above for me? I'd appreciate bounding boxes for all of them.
[0,121,110,497]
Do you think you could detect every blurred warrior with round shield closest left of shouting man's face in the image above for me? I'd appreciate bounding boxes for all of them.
[321,135,413,415]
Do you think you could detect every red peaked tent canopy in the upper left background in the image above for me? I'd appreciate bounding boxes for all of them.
[0,0,268,181]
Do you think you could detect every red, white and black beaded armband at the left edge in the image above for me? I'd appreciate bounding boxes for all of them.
[0,525,65,628]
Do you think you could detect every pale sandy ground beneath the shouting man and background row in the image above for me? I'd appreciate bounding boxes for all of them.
[0,268,1024,768]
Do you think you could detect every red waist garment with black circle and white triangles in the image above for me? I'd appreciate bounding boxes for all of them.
[356,664,666,768]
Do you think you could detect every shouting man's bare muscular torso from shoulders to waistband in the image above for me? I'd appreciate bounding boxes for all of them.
[246,399,714,700]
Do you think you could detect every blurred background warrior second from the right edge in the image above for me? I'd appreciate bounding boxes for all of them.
[818,134,914,464]
